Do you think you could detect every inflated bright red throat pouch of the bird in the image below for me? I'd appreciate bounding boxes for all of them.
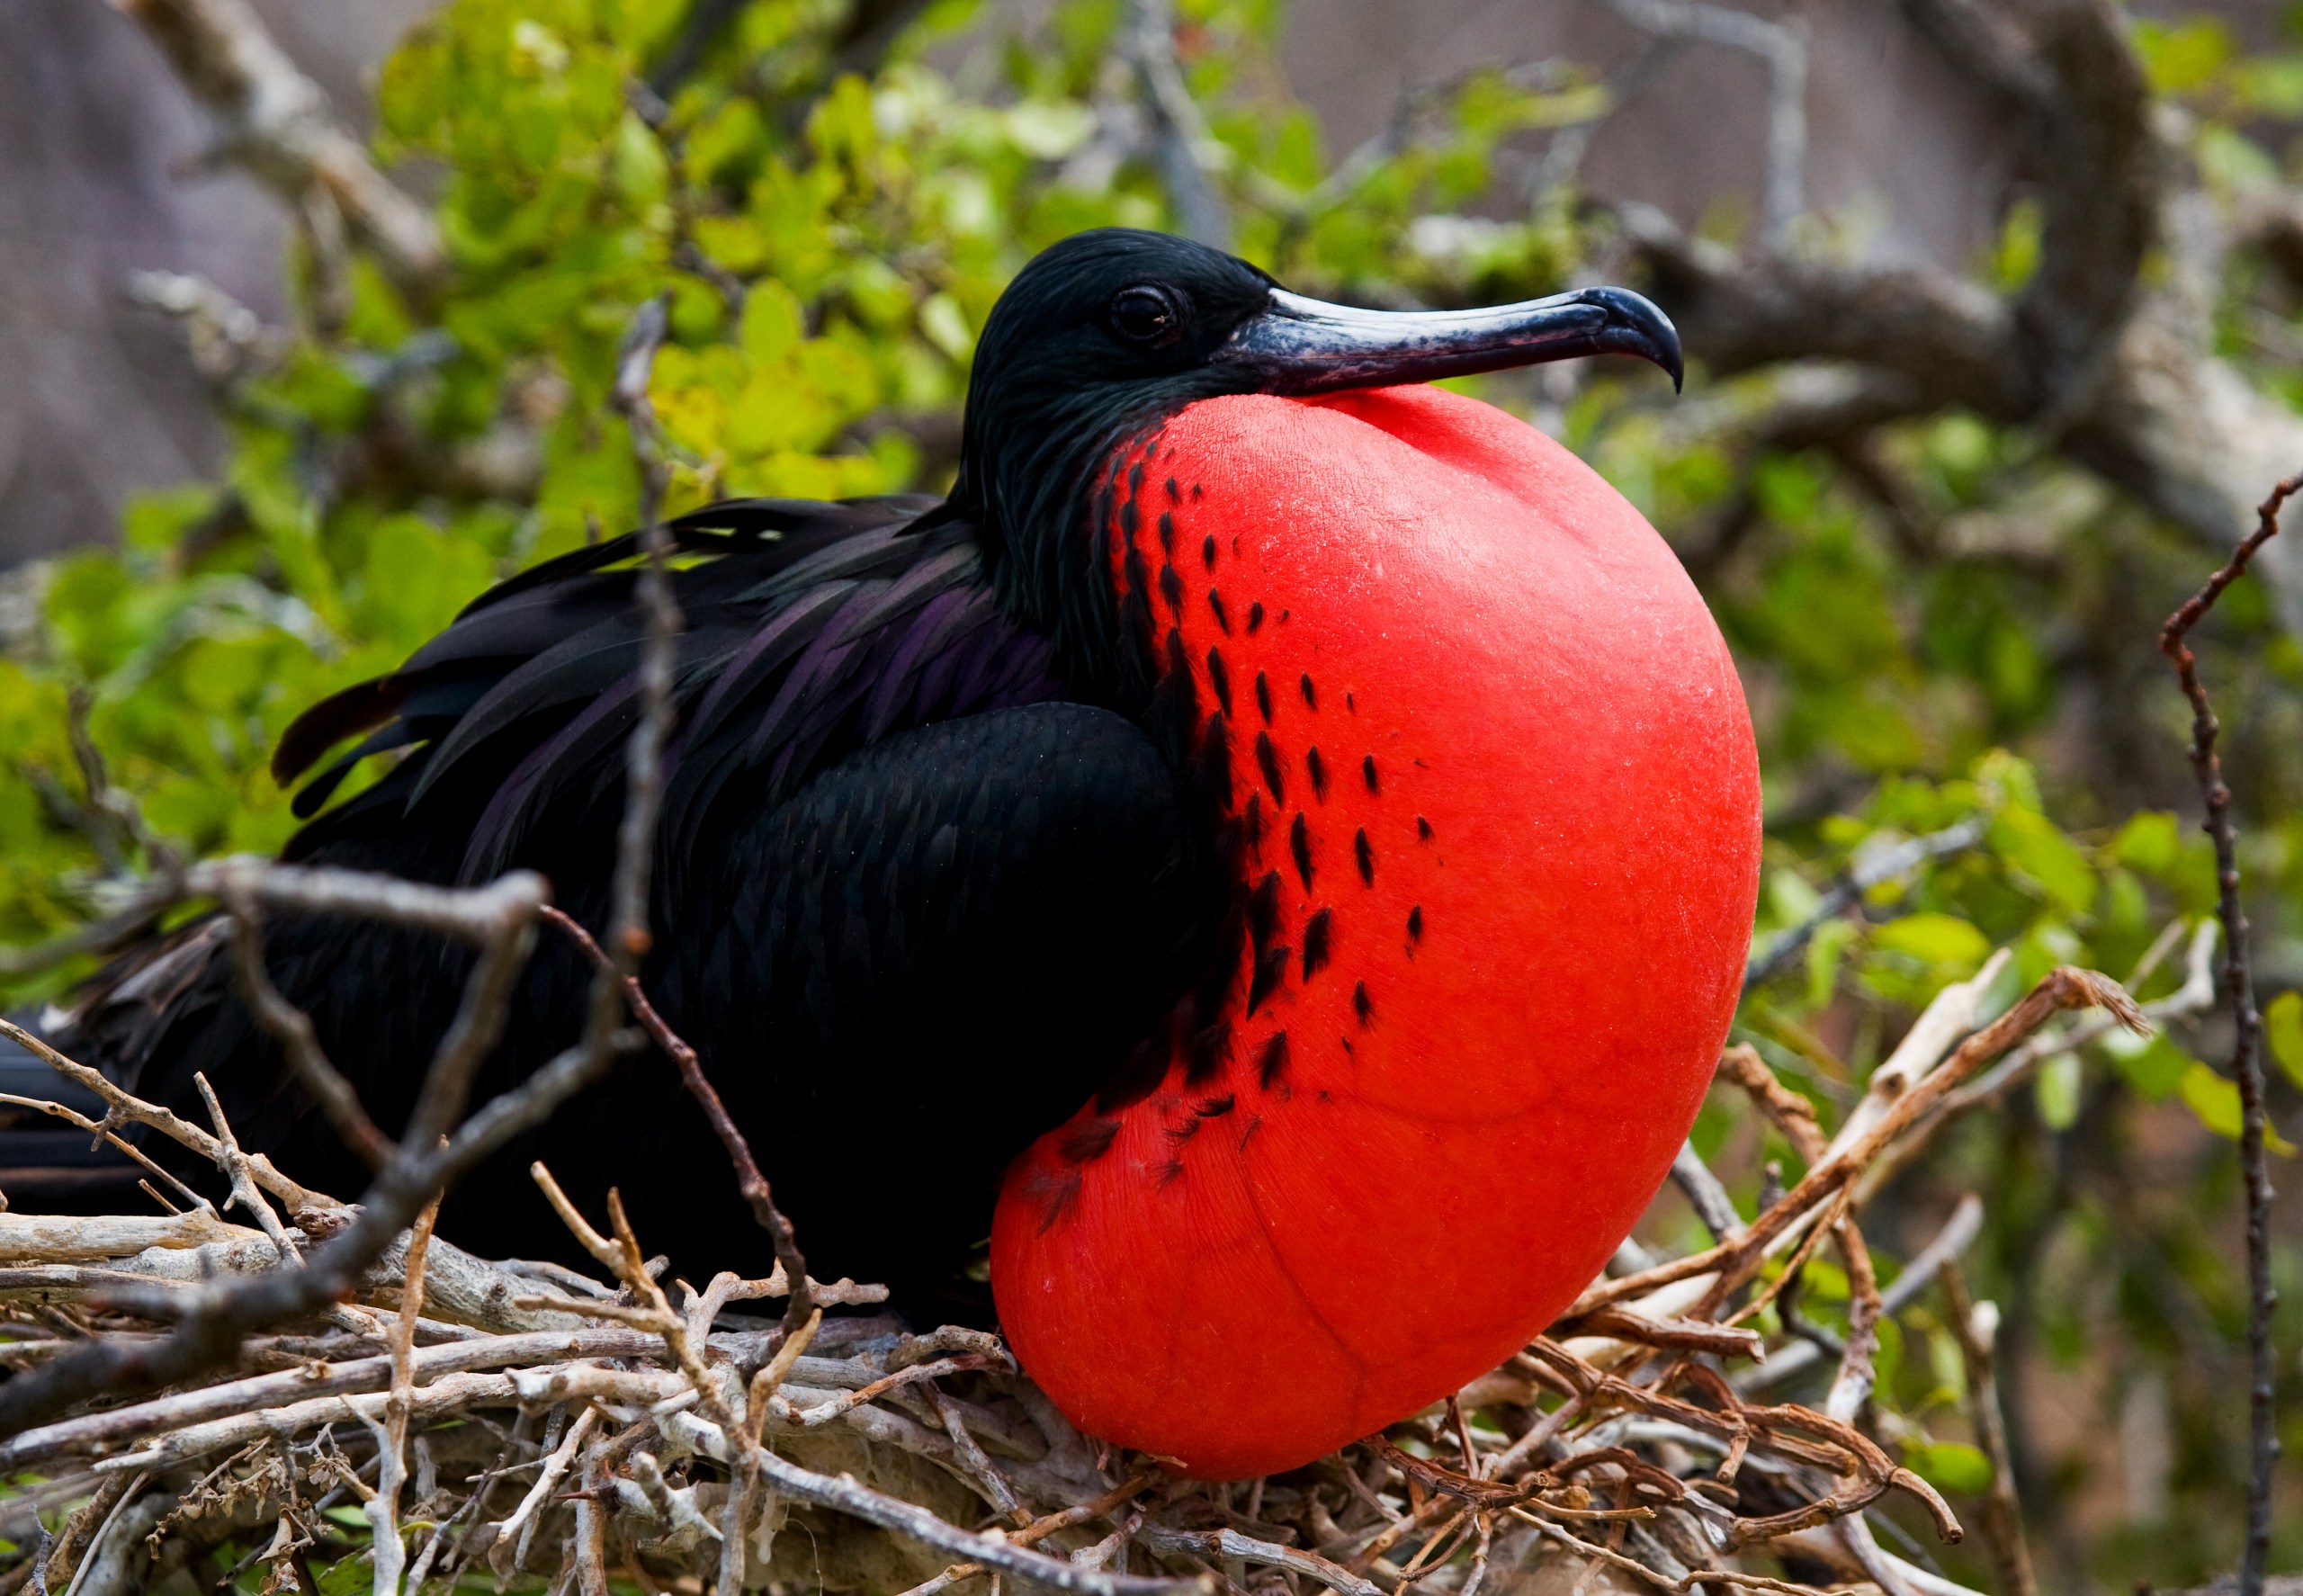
[990,387,1760,1478]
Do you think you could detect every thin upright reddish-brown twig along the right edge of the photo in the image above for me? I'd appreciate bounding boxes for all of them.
[2160,474,2303,1596]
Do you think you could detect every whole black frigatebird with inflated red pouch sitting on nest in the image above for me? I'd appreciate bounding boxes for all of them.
[4,230,1760,1476]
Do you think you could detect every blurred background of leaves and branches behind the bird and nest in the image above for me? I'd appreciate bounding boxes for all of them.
[13,0,2303,1592]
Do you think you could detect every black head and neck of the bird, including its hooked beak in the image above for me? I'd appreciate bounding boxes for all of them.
[951,228,1681,690]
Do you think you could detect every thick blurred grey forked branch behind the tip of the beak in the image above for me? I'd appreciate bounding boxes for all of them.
[1617,0,2303,636]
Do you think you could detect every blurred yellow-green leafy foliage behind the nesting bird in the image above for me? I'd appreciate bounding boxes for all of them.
[0,0,2303,1589]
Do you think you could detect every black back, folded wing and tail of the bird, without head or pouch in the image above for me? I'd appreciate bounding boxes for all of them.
[0,499,1215,1308]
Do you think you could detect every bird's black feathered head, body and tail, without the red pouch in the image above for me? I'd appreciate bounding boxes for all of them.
[0,230,1677,1313]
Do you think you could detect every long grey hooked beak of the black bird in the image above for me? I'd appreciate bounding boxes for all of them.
[1209,288,1683,394]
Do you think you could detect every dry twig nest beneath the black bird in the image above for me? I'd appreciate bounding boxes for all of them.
[0,866,2164,1596]
